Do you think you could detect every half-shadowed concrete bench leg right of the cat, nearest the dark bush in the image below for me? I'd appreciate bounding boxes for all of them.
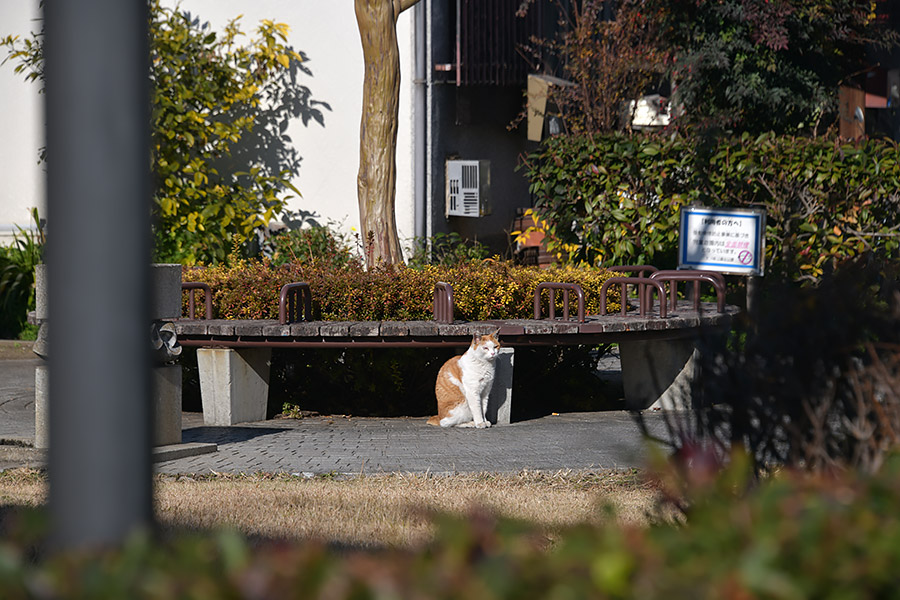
[619,339,697,410]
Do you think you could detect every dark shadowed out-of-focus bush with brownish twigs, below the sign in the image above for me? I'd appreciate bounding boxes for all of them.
[648,260,900,473]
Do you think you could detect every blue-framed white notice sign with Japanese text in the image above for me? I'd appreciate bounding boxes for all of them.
[678,206,766,275]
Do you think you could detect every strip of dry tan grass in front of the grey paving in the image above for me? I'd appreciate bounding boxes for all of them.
[0,470,657,547]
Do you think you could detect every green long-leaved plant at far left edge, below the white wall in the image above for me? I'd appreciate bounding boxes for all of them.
[0,208,45,339]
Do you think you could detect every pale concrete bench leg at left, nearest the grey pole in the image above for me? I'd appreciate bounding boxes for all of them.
[197,348,272,426]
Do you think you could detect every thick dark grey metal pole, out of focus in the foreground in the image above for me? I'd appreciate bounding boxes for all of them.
[45,0,153,549]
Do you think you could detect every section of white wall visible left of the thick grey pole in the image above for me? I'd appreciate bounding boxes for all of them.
[0,0,45,244]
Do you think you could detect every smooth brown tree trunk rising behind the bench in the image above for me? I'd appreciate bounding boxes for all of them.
[354,0,418,267]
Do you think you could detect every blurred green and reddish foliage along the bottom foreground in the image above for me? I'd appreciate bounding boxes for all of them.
[0,457,900,600]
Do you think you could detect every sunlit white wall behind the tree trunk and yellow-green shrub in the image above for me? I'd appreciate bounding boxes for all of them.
[0,0,414,250]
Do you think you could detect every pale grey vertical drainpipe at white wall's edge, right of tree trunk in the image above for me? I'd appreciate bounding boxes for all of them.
[413,2,429,238]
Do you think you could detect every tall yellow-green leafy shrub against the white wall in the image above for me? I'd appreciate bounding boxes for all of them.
[0,0,329,264]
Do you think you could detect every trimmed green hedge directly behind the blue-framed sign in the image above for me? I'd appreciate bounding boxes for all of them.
[524,133,900,280]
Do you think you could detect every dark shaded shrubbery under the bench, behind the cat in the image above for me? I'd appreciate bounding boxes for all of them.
[264,339,624,421]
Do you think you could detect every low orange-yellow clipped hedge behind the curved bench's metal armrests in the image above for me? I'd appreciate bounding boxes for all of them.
[184,260,619,321]
